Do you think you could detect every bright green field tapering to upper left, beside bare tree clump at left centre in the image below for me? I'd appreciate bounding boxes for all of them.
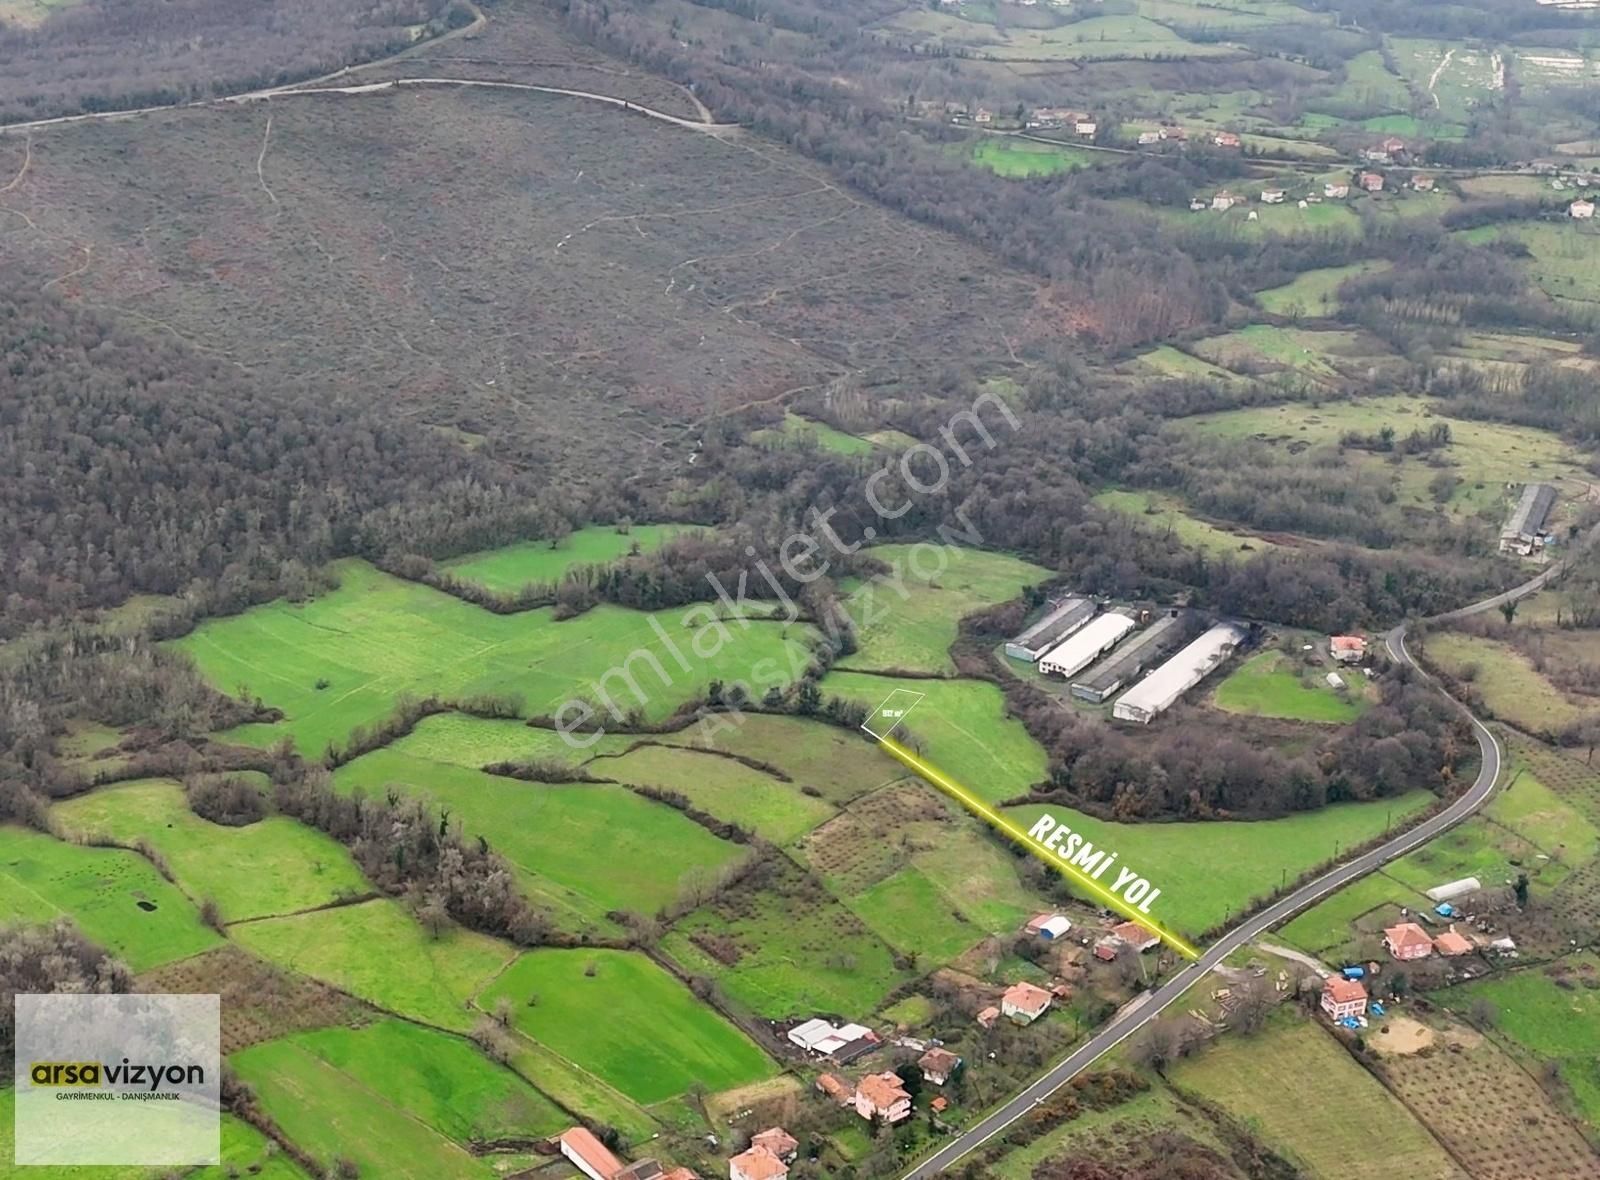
[334,739,742,931]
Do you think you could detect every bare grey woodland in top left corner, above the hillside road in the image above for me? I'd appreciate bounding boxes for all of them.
[0,0,470,122]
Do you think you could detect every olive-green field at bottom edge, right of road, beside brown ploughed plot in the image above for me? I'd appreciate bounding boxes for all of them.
[1170,1012,1461,1180]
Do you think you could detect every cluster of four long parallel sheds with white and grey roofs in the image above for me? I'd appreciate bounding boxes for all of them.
[1005,596,1250,724]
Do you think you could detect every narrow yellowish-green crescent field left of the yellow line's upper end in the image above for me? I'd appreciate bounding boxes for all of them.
[586,745,834,844]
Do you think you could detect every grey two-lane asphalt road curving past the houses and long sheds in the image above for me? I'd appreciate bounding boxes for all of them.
[904,543,1600,1180]
